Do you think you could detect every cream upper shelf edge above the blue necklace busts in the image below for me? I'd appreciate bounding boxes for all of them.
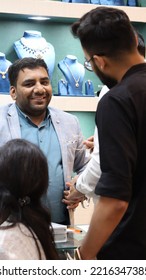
[0,0,146,22]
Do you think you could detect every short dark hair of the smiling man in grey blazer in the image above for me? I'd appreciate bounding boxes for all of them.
[8,57,49,86]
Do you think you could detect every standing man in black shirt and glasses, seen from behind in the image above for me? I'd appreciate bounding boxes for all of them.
[69,7,146,260]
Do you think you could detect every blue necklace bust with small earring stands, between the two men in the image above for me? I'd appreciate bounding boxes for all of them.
[58,55,94,96]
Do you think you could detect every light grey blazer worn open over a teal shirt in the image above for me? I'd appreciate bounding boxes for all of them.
[0,103,88,182]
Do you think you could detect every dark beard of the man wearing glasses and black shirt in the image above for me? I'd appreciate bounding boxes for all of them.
[94,64,117,89]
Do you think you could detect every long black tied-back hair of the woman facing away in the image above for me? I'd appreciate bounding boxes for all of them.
[0,139,59,259]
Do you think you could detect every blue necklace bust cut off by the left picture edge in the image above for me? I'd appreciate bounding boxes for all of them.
[0,52,12,94]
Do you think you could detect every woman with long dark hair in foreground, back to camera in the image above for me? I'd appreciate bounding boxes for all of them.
[0,139,59,260]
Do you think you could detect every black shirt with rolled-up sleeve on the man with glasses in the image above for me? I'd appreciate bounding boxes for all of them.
[95,63,146,260]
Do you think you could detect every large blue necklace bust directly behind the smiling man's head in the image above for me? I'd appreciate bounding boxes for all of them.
[14,30,55,79]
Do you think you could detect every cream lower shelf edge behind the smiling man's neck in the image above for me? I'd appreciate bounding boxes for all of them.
[0,94,98,112]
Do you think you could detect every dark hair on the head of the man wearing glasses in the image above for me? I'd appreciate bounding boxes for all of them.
[71,7,136,58]
